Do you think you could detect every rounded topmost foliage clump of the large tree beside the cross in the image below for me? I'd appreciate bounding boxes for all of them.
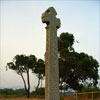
[58,32,74,57]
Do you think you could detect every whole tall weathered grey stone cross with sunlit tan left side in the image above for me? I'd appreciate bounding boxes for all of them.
[42,7,60,100]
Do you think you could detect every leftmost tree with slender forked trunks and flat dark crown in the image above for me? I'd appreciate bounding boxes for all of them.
[7,55,37,98]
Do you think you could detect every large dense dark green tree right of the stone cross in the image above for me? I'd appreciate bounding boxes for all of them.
[58,32,99,90]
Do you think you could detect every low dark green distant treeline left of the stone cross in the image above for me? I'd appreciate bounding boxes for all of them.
[0,88,44,98]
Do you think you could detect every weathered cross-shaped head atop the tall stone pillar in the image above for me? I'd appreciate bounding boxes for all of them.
[41,7,61,29]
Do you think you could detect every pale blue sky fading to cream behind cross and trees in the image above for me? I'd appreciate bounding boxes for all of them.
[0,0,100,89]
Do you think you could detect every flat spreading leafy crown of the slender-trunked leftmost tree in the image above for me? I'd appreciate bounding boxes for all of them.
[7,55,37,75]
